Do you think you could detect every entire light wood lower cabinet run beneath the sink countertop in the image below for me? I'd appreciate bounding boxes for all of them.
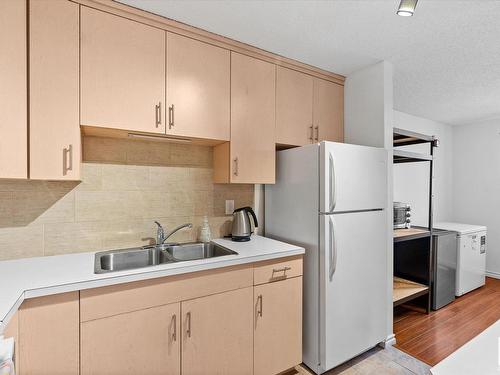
[5,257,302,375]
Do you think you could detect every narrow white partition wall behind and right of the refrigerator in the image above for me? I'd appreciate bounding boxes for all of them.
[344,61,394,341]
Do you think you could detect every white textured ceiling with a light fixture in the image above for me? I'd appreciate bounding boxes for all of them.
[120,0,500,124]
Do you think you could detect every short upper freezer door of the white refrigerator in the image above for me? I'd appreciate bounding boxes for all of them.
[319,142,387,213]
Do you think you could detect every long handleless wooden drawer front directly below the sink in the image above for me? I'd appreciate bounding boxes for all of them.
[84,265,253,322]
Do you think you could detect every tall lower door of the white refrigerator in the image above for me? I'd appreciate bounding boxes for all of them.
[317,211,389,373]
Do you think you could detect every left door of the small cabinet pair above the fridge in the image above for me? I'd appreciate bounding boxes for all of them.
[276,66,313,146]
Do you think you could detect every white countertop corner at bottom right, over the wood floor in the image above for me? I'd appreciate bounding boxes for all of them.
[431,320,500,375]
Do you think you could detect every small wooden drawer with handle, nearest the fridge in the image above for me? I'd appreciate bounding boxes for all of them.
[253,256,302,285]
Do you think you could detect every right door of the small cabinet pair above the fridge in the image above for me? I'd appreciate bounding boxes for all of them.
[313,78,344,142]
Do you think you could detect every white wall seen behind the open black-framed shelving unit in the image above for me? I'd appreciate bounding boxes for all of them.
[394,111,453,226]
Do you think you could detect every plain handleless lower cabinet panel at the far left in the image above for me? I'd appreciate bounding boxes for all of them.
[17,294,80,375]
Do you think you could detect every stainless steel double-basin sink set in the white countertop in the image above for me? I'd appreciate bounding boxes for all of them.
[94,242,238,273]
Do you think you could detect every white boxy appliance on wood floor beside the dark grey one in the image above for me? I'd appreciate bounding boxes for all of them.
[434,223,486,296]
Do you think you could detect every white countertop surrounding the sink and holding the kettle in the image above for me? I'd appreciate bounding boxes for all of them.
[0,235,304,334]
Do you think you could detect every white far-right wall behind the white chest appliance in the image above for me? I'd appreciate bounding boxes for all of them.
[453,119,500,277]
